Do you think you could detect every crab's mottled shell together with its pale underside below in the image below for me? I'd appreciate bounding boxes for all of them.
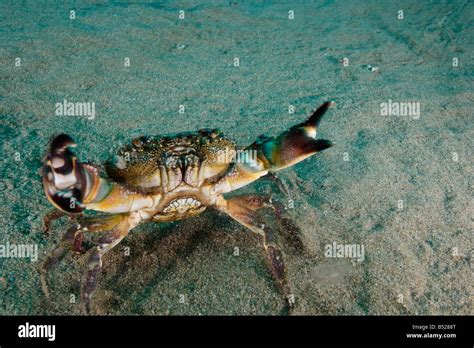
[105,129,236,221]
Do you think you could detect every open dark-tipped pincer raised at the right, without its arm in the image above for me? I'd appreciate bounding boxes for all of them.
[249,102,334,171]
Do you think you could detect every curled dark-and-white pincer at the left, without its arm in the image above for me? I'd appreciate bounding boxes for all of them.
[42,134,87,213]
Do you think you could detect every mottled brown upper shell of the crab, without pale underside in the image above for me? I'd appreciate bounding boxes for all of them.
[105,129,235,193]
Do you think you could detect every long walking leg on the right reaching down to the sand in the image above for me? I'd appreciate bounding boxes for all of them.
[216,197,294,308]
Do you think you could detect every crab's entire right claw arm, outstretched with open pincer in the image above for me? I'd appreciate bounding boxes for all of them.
[212,102,333,193]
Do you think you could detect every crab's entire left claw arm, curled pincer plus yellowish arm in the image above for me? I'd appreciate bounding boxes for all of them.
[43,134,157,214]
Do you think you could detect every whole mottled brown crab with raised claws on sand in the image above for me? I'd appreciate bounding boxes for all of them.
[40,102,333,313]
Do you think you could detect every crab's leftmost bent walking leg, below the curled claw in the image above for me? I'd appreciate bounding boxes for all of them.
[40,214,127,297]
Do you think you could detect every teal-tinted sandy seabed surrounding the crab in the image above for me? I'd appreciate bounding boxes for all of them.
[0,1,474,315]
